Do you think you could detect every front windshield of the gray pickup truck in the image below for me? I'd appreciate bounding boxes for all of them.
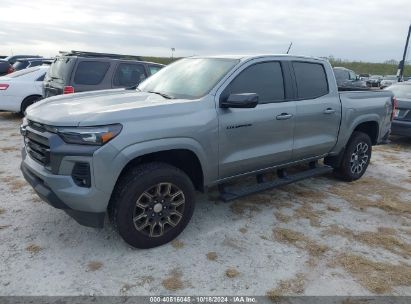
[138,58,239,99]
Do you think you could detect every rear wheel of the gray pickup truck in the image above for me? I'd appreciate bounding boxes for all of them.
[336,131,372,182]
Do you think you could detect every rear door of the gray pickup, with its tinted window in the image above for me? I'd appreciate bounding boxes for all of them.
[291,61,341,161]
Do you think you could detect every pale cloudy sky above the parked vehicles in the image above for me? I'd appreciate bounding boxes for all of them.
[0,0,411,62]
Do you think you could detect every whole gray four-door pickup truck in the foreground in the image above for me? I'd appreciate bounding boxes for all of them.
[21,55,394,248]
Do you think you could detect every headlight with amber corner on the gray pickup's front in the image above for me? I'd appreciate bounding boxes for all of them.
[56,124,123,146]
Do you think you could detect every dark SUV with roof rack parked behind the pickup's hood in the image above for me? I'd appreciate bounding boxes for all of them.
[43,51,164,98]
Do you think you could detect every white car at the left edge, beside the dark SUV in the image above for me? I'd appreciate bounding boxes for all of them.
[0,66,49,114]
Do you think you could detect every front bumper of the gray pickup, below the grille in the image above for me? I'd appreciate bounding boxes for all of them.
[20,148,107,228]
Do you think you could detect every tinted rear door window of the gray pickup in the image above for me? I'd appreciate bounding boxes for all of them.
[293,62,328,99]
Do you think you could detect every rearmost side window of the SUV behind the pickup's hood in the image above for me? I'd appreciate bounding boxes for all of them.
[74,61,110,85]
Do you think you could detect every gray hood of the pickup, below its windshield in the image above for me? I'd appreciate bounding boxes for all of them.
[26,89,195,126]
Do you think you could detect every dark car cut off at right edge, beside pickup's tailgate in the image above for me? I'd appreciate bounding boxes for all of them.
[385,81,411,137]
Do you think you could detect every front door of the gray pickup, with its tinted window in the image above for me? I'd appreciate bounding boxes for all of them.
[217,60,296,179]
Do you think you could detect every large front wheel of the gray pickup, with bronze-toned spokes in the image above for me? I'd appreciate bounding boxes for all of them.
[108,162,195,248]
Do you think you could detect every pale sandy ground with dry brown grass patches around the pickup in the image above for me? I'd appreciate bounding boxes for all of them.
[0,113,411,298]
